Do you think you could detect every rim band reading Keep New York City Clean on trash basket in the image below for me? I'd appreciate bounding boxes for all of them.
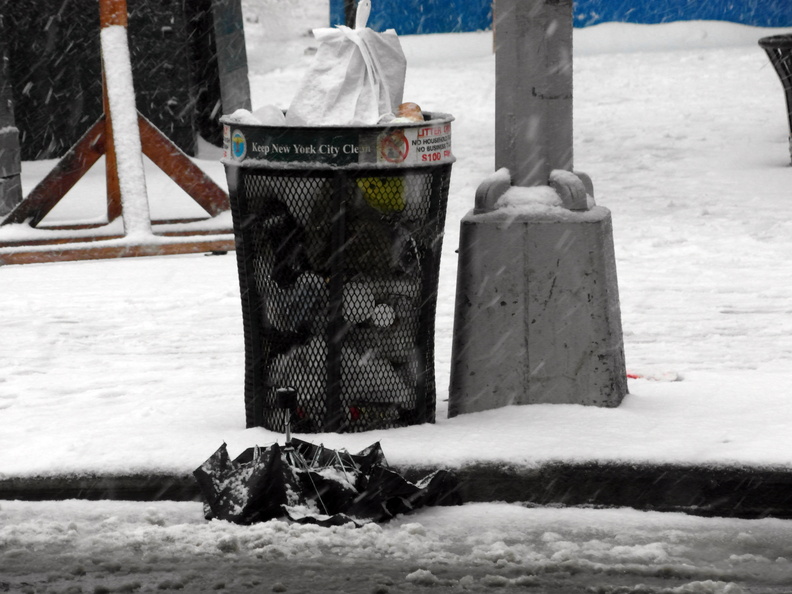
[220,112,456,169]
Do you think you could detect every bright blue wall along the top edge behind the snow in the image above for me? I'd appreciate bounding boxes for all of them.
[330,0,792,35]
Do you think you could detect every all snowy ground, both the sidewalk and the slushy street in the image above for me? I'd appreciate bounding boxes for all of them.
[0,1,792,594]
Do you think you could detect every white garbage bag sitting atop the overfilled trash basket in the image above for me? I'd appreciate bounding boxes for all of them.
[286,0,407,126]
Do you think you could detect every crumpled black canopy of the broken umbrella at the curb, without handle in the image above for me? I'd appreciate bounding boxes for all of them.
[193,439,461,526]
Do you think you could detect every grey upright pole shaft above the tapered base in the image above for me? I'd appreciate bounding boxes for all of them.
[495,0,572,186]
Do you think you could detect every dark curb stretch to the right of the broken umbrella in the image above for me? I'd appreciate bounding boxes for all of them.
[436,462,792,518]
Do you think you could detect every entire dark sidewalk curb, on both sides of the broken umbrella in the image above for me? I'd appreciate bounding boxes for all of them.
[0,462,792,519]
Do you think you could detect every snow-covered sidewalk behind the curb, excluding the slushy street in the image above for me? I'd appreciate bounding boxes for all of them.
[0,14,792,477]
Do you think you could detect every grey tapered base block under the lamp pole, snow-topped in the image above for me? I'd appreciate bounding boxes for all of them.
[448,207,627,416]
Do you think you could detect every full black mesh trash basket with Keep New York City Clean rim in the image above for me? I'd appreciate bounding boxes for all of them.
[222,113,454,433]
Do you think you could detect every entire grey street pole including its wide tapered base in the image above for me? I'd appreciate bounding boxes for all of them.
[448,0,627,416]
